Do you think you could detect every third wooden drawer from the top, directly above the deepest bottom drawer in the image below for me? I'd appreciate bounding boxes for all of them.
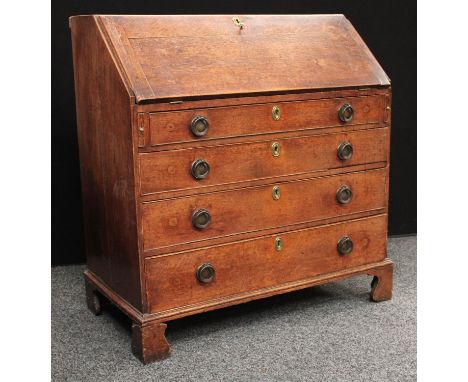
[141,168,387,250]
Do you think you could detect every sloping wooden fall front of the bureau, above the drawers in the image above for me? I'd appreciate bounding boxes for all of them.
[70,15,390,103]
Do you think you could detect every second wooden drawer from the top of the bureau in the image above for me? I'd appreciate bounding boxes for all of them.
[140,128,388,195]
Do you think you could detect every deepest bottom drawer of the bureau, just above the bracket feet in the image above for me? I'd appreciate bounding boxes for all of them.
[145,215,387,313]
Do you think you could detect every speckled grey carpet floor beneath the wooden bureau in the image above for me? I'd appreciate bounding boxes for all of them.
[52,236,416,382]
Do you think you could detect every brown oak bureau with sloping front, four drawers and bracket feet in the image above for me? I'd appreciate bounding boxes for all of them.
[70,15,393,363]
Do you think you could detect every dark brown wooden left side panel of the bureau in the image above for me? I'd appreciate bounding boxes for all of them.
[71,16,142,309]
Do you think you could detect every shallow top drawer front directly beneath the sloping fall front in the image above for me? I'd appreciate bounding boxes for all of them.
[149,95,386,146]
